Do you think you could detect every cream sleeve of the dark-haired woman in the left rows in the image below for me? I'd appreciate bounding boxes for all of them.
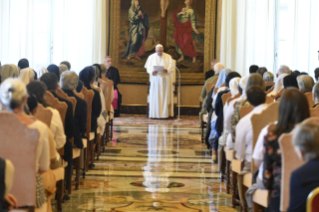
[50,109,66,149]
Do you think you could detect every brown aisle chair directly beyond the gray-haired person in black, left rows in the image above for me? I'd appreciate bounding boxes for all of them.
[82,87,95,171]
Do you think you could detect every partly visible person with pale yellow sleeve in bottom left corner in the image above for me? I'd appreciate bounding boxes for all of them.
[0,158,18,211]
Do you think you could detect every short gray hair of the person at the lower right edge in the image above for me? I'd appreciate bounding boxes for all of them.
[292,123,319,161]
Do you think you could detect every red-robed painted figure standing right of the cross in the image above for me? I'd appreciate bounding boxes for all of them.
[173,0,199,63]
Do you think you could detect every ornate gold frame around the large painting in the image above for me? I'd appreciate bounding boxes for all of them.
[109,0,217,85]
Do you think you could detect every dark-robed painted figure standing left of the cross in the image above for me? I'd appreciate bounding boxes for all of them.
[122,0,149,60]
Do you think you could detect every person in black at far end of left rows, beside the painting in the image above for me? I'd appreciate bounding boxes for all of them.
[101,56,122,117]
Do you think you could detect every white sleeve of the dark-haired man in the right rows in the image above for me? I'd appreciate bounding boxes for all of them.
[234,119,246,161]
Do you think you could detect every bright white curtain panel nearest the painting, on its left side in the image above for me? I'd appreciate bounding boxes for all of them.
[52,0,109,72]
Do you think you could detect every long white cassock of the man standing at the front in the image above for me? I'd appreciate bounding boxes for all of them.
[145,53,175,118]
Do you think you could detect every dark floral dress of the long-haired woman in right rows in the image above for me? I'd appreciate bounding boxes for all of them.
[263,132,281,211]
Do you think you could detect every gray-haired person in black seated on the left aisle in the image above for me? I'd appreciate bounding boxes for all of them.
[60,71,87,149]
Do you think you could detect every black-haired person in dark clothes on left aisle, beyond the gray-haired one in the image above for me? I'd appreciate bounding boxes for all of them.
[79,66,102,143]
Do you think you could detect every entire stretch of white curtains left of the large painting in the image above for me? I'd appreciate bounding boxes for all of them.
[0,0,109,72]
